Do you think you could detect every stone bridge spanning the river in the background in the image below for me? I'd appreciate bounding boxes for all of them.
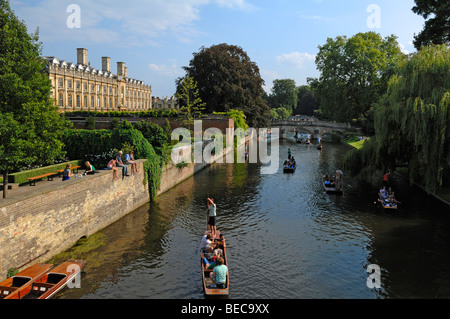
[271,120,360,139]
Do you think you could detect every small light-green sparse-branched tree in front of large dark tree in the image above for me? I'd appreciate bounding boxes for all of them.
[175,76,206,125]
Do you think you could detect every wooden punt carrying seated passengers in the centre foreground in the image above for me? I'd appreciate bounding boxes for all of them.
[200,231,230,297]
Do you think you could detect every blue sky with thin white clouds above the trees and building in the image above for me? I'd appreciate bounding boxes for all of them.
[10,0,424,97]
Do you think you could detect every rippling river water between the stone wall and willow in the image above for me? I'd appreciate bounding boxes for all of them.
[57,141,450,299]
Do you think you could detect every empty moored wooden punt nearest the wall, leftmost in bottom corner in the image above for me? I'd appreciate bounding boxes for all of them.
[0,263,53,299]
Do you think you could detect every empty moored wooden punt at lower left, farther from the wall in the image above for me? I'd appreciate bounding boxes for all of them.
[4,259,86,299]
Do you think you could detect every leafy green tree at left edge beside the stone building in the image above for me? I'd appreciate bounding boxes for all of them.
[0,0,69,197]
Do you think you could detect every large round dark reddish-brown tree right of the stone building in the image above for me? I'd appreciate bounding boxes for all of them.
[177,43,270,127]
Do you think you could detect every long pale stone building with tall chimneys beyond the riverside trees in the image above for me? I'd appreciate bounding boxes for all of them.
[44,48,152,112]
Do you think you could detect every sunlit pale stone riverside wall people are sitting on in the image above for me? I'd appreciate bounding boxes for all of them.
[0,134,248,281]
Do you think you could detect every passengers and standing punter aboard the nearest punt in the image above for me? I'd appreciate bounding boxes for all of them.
[200,198,228,289]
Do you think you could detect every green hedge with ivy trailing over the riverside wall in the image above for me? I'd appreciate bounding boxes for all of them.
[63,129,162,199]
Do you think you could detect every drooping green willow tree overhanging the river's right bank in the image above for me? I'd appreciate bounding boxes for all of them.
[345,45,450,192]
